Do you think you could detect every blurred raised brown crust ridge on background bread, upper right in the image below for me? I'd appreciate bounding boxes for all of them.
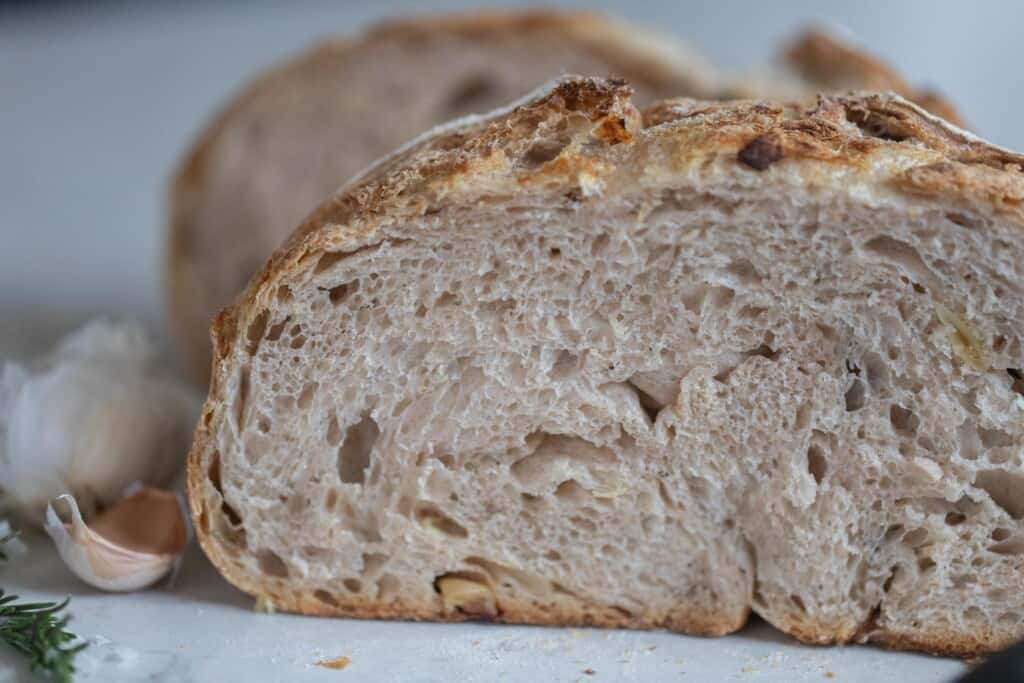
[782,29,964,126]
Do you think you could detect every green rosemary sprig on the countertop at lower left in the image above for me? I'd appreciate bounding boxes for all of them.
[0,588,88,683]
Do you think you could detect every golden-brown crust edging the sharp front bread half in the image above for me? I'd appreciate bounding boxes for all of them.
[188,78,1024,655]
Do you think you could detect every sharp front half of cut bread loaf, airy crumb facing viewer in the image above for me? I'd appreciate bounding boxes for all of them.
[188,78,1024,655]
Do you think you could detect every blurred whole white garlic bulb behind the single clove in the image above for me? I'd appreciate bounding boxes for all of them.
[0,323,200,522]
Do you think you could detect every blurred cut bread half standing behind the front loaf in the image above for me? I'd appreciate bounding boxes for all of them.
[166,12,958,381]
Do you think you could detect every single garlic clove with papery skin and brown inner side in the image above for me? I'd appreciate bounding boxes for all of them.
[45,488,189,592]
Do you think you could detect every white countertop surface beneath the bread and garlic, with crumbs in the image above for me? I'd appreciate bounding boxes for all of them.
[0,537,965,683]
